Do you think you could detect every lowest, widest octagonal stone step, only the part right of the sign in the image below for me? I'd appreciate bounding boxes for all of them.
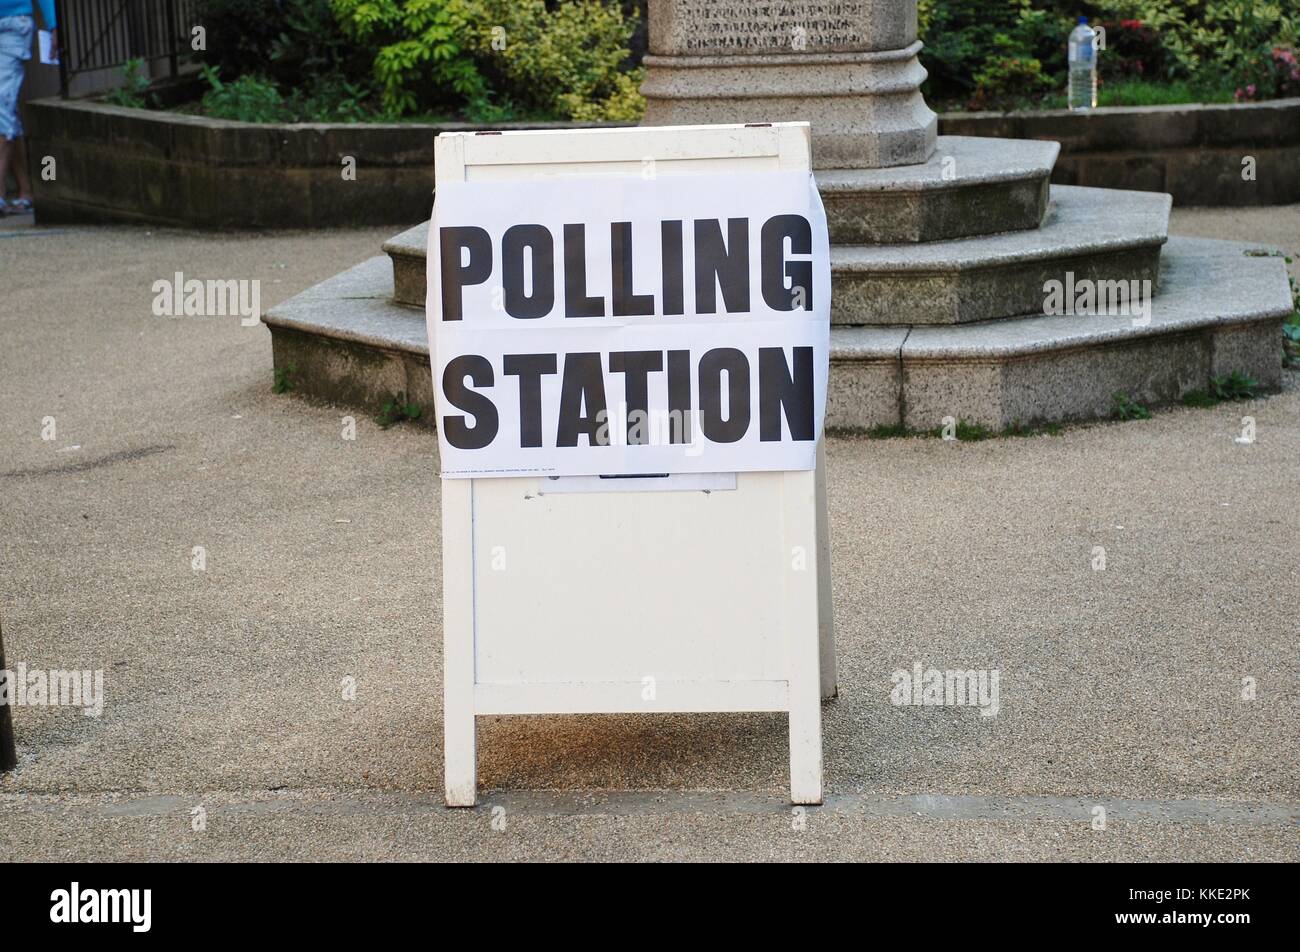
[827,238,1292,430]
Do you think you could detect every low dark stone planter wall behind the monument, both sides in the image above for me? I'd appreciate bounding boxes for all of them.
[25,99,1300,228]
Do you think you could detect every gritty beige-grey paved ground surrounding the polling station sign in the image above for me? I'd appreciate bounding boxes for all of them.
[0,205,1300,861]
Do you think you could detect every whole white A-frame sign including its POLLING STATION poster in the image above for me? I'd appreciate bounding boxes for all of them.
[428,122,835,806]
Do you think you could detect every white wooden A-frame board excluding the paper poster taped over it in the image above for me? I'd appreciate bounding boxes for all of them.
[429,122,836,806]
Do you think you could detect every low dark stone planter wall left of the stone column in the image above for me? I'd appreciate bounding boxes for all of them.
[25,99,613,229]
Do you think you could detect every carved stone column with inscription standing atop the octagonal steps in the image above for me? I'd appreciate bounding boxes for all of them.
[641,0,937,169]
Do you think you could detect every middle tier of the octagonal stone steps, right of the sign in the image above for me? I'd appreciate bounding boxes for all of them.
[831,185,1170,325]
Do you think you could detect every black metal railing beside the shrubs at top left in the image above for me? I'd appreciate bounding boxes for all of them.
[55,0,199,99]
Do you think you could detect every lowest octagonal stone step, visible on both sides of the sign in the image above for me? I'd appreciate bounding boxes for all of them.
[264,238,1292,429]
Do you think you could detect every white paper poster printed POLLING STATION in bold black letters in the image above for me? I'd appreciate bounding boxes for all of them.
[426,172,831,477]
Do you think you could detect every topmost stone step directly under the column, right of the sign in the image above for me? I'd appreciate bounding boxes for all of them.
[815,135,1061,245]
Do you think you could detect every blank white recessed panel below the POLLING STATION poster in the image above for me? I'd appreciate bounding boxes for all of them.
[472,473,790,685]
